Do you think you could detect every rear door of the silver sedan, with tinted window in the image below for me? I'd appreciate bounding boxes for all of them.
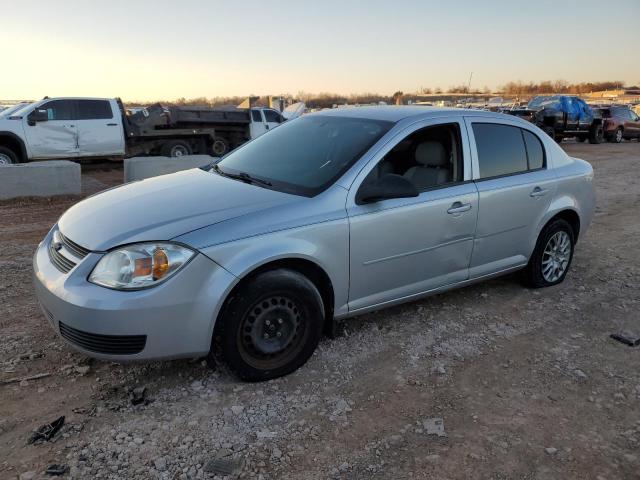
[466,117,556,278]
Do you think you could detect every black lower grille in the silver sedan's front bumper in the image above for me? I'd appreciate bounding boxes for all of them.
[58,322,147,355]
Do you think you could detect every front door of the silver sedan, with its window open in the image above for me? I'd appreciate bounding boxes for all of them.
[347,118,478,311]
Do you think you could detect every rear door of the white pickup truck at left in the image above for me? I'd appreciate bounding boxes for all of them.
[76,99,124,157]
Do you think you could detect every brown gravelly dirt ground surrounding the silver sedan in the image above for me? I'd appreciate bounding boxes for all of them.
[0,142,640,480]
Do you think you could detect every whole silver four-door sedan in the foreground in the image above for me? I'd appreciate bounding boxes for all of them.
[33,107,595,381]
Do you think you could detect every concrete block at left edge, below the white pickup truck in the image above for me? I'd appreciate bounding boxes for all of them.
[0,160,81,200]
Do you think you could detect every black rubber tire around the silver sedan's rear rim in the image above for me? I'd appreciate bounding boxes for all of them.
[523,218,575,288]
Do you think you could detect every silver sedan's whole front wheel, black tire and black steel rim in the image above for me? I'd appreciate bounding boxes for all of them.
[210,269,325,382]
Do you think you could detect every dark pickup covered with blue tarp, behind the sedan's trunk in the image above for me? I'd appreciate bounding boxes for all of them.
[505,95,604,143]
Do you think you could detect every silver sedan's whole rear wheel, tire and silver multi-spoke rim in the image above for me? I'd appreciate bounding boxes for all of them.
[524,218,575,288]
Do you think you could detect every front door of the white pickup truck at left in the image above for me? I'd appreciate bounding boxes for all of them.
[24,99,78,159]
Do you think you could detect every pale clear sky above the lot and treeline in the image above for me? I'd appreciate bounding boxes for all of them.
[0,0,640,101]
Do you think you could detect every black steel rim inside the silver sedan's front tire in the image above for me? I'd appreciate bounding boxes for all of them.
[238,295,306,369]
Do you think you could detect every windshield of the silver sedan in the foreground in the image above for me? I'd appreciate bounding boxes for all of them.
[217,116,393,196]
